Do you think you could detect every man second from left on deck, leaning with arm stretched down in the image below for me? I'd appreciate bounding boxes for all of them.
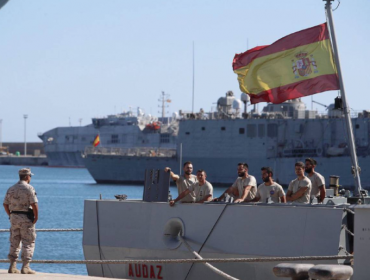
[170,169,213,206]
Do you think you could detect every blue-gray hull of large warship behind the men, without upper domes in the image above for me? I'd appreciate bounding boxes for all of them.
[84,115,370,188]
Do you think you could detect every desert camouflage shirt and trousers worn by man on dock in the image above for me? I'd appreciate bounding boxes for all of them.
[4,181,38,261]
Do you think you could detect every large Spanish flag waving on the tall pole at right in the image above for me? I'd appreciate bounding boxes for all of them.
[233,23,340,104]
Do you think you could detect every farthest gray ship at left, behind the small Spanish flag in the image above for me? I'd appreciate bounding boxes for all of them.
[39,109,178,167]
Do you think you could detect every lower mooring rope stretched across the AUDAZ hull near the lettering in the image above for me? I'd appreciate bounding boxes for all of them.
[0,255,353,264]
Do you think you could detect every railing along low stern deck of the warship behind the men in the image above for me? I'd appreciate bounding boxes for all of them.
[85,147,176,157]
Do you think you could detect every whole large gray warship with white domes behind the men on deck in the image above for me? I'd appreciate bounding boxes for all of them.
[83,91,370,187]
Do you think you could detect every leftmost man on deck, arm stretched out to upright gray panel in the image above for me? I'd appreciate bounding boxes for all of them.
[164,161,197,203]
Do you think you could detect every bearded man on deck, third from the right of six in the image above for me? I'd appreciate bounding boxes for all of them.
[252,167,286,203]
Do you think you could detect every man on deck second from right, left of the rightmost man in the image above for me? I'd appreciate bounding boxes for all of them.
[286,161,311,203]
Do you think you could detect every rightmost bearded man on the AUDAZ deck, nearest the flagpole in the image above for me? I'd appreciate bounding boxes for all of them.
[305,158,326,203]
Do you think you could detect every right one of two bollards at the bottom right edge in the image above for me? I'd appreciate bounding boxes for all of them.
[308,264,353,280]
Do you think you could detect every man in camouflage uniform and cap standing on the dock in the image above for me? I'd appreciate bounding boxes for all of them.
[3,168,38,274]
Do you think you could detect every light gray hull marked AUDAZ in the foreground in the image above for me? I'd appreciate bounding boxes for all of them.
[83,200,370,280]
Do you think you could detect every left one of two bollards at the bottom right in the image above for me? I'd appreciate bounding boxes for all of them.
[273,263,314,280]
